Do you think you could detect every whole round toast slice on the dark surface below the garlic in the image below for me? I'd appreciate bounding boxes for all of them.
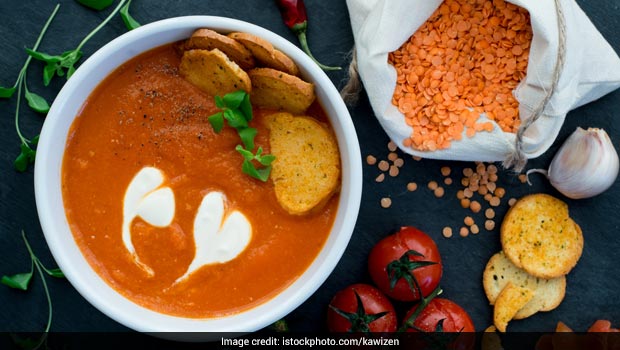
[500,194,583,279]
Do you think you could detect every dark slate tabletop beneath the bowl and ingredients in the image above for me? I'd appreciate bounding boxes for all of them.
[0,0,620,331]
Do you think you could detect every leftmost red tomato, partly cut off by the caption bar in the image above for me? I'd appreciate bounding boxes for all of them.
[327,283,398,332]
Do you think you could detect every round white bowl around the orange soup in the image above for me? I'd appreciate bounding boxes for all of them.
[34,16,362,340]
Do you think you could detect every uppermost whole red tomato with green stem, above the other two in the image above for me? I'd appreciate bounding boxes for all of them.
[368,227,443,301]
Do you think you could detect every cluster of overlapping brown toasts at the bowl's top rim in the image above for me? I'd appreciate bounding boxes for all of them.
[179,28,316,114]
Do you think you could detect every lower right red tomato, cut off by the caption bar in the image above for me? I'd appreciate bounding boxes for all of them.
[404,298,476,350]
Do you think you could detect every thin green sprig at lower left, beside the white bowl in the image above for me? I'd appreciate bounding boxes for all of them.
[0,230,65,350]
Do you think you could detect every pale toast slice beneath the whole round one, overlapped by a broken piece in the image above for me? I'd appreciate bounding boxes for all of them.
[482,252,566,320]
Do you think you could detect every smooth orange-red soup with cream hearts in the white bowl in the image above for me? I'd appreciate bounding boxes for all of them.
[62,45,338,318]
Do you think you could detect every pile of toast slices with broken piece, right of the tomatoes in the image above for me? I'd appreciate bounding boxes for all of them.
[482,194,583,332]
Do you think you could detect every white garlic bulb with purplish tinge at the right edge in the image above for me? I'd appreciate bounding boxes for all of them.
[527,127,618,199]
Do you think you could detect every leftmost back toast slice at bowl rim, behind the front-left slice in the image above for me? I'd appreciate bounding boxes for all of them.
[185,28,256,70]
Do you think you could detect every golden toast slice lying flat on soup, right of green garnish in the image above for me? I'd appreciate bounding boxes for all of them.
[265,113,340,215]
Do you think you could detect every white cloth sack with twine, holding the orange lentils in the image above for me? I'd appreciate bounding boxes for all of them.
[347,0,620,168]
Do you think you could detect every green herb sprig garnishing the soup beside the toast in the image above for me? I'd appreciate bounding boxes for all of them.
[209,90,276,182]
